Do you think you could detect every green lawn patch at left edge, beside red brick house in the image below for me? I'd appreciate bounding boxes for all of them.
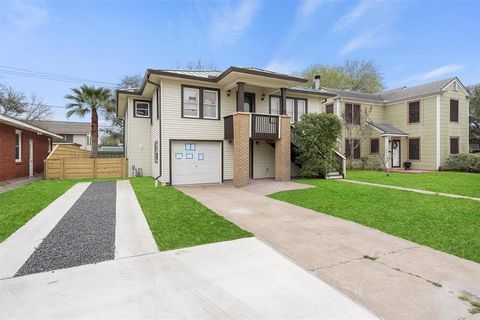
[0,180,78,242]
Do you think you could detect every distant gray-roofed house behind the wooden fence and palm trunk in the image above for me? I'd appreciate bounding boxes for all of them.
[32,121,92,151]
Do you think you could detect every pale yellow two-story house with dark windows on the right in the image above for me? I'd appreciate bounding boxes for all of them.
[323,77,470,170]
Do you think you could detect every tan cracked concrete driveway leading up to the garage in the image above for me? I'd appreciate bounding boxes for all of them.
[179,182,480,320]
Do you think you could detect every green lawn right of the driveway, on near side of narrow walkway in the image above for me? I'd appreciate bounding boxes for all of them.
[271,180,480,262]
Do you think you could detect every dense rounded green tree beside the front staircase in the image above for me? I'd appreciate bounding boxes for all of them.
[293,113,342,177]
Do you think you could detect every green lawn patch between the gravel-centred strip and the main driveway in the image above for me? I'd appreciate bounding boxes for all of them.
[130,178,252,250]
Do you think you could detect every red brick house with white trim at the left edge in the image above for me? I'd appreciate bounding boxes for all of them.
[0,115,62,181]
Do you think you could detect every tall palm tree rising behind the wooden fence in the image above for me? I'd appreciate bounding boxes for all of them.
[65,84,112,158]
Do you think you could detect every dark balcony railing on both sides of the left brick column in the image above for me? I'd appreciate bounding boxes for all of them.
[223,113,280,140]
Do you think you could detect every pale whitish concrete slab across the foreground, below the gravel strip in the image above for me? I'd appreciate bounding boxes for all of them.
[0,238,376,320]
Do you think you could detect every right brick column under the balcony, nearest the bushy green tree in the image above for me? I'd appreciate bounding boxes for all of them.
[275,116,292,181]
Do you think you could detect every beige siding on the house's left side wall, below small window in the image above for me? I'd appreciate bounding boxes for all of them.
[126,98,152,176]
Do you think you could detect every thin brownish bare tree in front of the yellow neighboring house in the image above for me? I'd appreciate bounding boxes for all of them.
[342,104,373,168]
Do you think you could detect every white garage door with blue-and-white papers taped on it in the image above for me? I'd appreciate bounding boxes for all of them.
[171,141,222,185]
